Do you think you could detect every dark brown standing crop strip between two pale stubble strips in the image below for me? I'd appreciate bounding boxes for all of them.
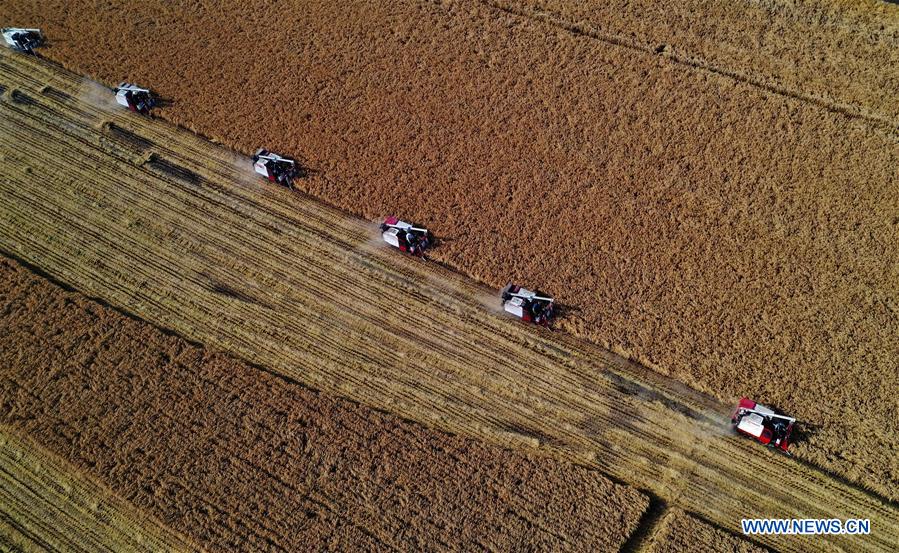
[0,260,648,551]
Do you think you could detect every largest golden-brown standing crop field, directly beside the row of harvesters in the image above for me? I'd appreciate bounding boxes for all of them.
[0,0,899,496]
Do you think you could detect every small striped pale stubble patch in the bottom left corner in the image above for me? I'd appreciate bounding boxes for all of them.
[0,426,197,553]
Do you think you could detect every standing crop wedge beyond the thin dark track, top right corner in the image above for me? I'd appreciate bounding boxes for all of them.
[485,0,899,124]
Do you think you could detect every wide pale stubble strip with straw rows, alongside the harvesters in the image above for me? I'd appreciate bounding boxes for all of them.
[0,48,899,551]
